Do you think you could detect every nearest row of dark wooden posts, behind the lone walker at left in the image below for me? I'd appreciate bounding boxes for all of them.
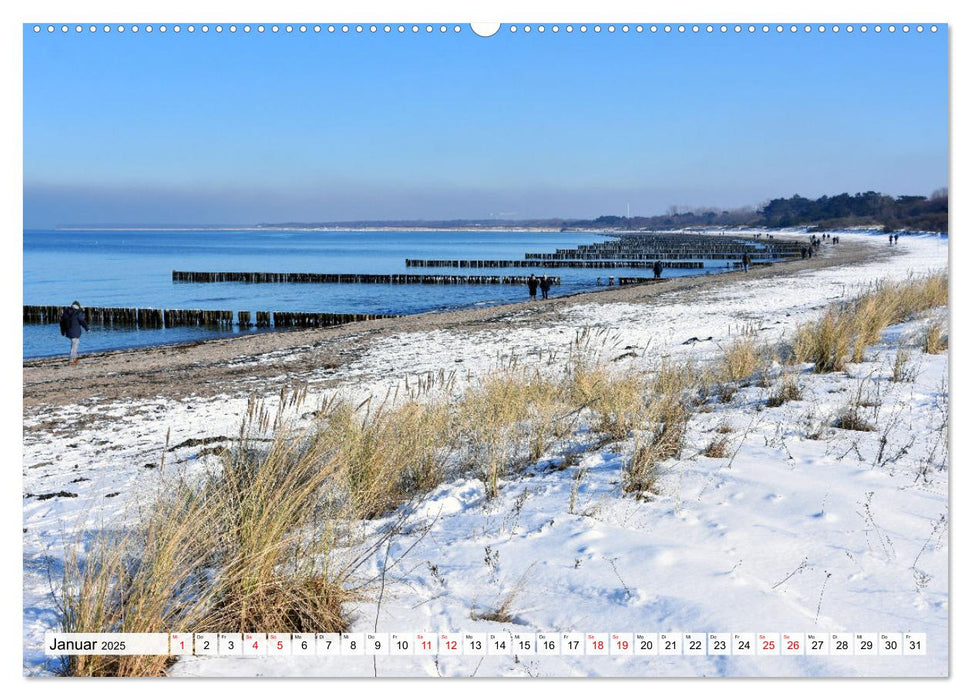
[24,305,394,329]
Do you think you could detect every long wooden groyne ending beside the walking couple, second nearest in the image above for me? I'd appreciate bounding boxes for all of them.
[172,270,560,284]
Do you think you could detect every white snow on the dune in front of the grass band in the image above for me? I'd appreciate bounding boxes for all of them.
[173,324,948,677]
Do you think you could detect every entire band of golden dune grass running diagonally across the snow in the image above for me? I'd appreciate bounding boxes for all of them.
[53,273,947,676]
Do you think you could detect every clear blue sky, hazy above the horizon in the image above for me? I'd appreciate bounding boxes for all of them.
[24,25,948,228]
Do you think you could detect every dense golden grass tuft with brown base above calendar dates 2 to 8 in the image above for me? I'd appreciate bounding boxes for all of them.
[205,429,354,632]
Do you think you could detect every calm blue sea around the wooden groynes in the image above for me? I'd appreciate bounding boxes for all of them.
[23,230,724,357]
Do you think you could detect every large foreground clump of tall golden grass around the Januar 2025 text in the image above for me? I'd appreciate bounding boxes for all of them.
[61,410,372,676]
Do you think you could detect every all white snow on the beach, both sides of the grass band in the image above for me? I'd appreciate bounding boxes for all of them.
[23,233,949,677]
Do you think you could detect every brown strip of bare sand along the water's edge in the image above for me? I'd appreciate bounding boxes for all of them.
[23,240,891,416]
